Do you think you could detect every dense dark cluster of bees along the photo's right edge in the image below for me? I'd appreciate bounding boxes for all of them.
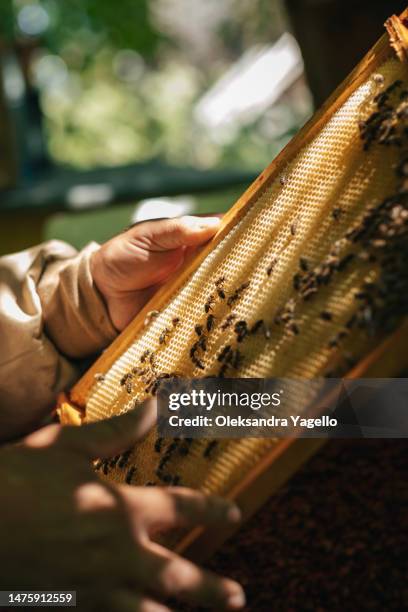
[349,80,408,335]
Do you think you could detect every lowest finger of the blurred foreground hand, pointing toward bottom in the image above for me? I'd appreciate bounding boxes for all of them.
[142,542,245,610]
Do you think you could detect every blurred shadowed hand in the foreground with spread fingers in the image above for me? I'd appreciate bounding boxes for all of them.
[0,402,244,612]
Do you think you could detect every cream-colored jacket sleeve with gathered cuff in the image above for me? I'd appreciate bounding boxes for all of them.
[0,240,116,440]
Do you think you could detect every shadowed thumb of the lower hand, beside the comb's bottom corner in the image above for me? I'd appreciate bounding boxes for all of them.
[59,398,157,459]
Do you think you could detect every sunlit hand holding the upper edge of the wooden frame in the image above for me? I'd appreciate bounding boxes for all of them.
[91,217,220,331]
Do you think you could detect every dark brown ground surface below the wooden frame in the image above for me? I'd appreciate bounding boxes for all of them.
[190,440,408,612]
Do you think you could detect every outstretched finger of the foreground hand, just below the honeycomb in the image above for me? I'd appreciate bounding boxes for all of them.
[114,485,241,531]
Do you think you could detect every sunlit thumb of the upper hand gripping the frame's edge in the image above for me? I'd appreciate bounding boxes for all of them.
[130,216,221,251]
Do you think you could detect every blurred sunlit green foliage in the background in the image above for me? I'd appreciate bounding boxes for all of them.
[0,0,310,175]
